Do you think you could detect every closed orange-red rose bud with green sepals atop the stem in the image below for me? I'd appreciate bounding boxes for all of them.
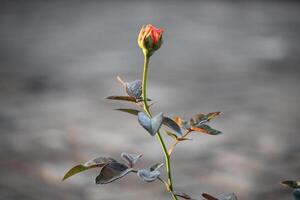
[138,24,164,56]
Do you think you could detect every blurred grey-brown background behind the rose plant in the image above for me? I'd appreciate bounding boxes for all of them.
[0,0,300,200]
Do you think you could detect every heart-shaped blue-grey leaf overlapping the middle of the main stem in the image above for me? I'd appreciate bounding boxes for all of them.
[138,112,164,136]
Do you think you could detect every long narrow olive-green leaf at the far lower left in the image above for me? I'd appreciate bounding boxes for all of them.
[62,157,116,181]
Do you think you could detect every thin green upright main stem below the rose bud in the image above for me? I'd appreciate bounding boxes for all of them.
[142,52,178,200]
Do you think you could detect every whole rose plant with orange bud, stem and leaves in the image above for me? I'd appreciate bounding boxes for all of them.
[63,24,237,200]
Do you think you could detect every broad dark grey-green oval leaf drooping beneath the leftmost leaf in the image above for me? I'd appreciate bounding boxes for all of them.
[95,162,132,184]
